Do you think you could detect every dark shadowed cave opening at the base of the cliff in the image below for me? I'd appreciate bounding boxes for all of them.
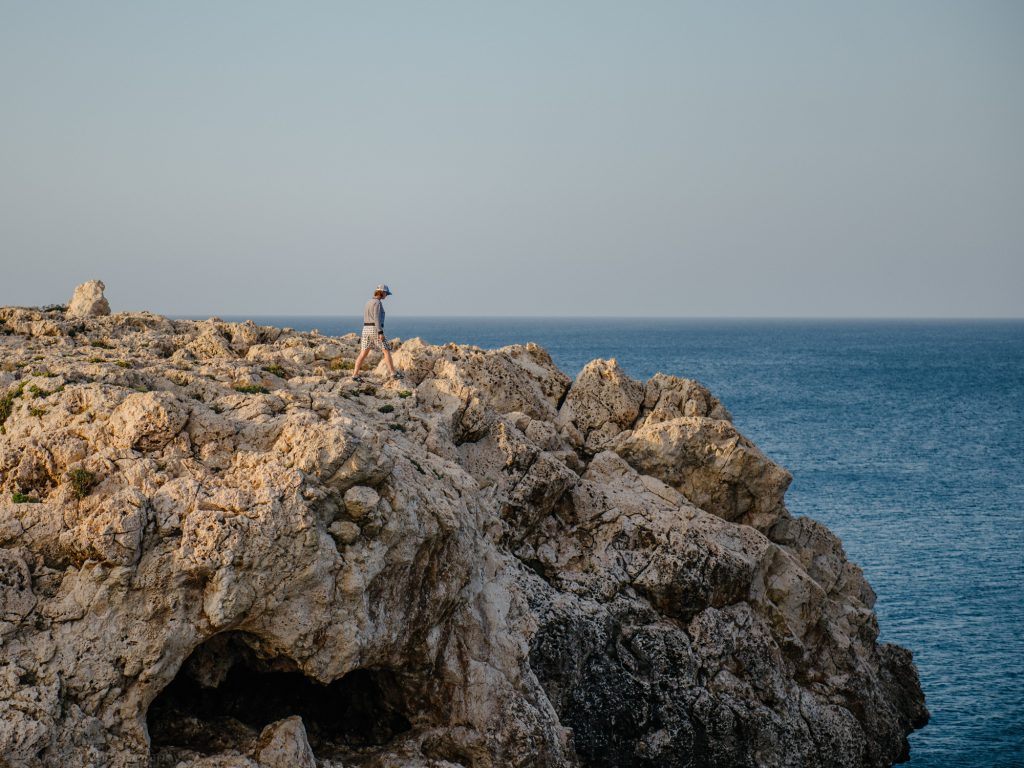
[146,633,412,765]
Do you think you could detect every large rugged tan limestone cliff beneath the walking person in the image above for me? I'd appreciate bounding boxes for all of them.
[0,302,928,768]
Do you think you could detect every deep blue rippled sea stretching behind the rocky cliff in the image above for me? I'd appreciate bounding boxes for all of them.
[216,316,1024,768]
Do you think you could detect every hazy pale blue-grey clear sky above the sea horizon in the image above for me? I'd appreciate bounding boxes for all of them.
[0,0,1024,317]
